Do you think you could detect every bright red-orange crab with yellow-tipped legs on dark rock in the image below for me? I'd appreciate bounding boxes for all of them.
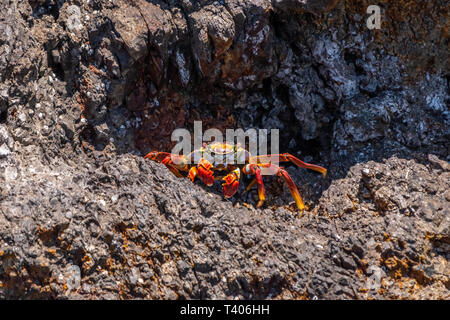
[144,142,327,211]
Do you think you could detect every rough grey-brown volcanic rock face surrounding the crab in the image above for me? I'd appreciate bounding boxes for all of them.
[0,0,450,299]
